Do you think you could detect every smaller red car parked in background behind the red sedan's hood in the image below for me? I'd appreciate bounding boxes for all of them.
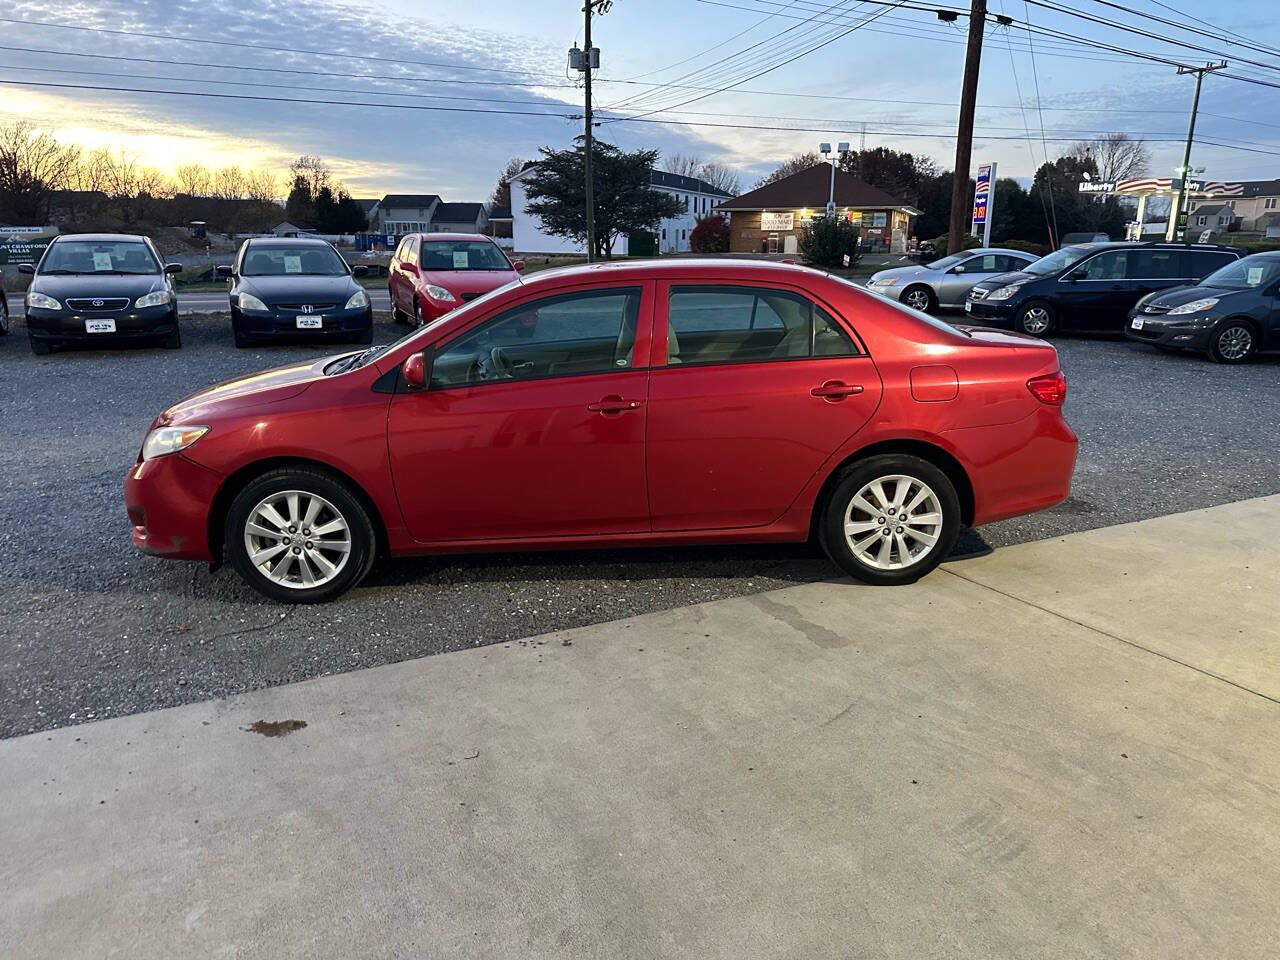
[387,233,525,326]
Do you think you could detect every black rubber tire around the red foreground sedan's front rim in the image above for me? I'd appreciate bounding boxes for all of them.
[223,467,378,603]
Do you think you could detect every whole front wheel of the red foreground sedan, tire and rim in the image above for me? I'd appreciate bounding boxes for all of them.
[224,467,376,603]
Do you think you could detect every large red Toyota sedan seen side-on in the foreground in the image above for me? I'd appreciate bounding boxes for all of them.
[124,260,1076,602]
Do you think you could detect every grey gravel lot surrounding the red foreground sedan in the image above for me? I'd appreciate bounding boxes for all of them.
[0,314,1280,736]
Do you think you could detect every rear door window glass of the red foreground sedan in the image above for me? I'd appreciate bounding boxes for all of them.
[667,285,859,364]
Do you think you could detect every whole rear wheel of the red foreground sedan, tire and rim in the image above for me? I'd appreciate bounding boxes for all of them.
[818,454,960,586]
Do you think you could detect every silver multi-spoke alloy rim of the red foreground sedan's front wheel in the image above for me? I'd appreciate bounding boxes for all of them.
[244,490,351,590]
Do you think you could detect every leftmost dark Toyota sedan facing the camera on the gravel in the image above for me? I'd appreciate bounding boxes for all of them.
[18,233,182,355]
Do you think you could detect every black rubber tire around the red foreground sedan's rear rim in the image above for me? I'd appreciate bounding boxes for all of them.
[818,453,960,586]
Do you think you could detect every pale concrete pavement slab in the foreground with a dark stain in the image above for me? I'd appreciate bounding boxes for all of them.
[0,497,1280,960]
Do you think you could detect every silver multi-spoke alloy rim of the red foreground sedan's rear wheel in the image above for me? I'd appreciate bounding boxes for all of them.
[845,475,943,570]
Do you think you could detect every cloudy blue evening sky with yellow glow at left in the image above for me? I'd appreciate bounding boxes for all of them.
[0,0,1280,201]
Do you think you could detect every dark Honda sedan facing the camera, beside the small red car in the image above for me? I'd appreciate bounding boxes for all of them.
[218,237,374,347]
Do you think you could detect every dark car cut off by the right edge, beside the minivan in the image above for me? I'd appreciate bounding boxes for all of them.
[1125,252,1280,364]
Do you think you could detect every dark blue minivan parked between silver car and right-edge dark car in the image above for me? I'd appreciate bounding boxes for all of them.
[964,243,1242,337]
